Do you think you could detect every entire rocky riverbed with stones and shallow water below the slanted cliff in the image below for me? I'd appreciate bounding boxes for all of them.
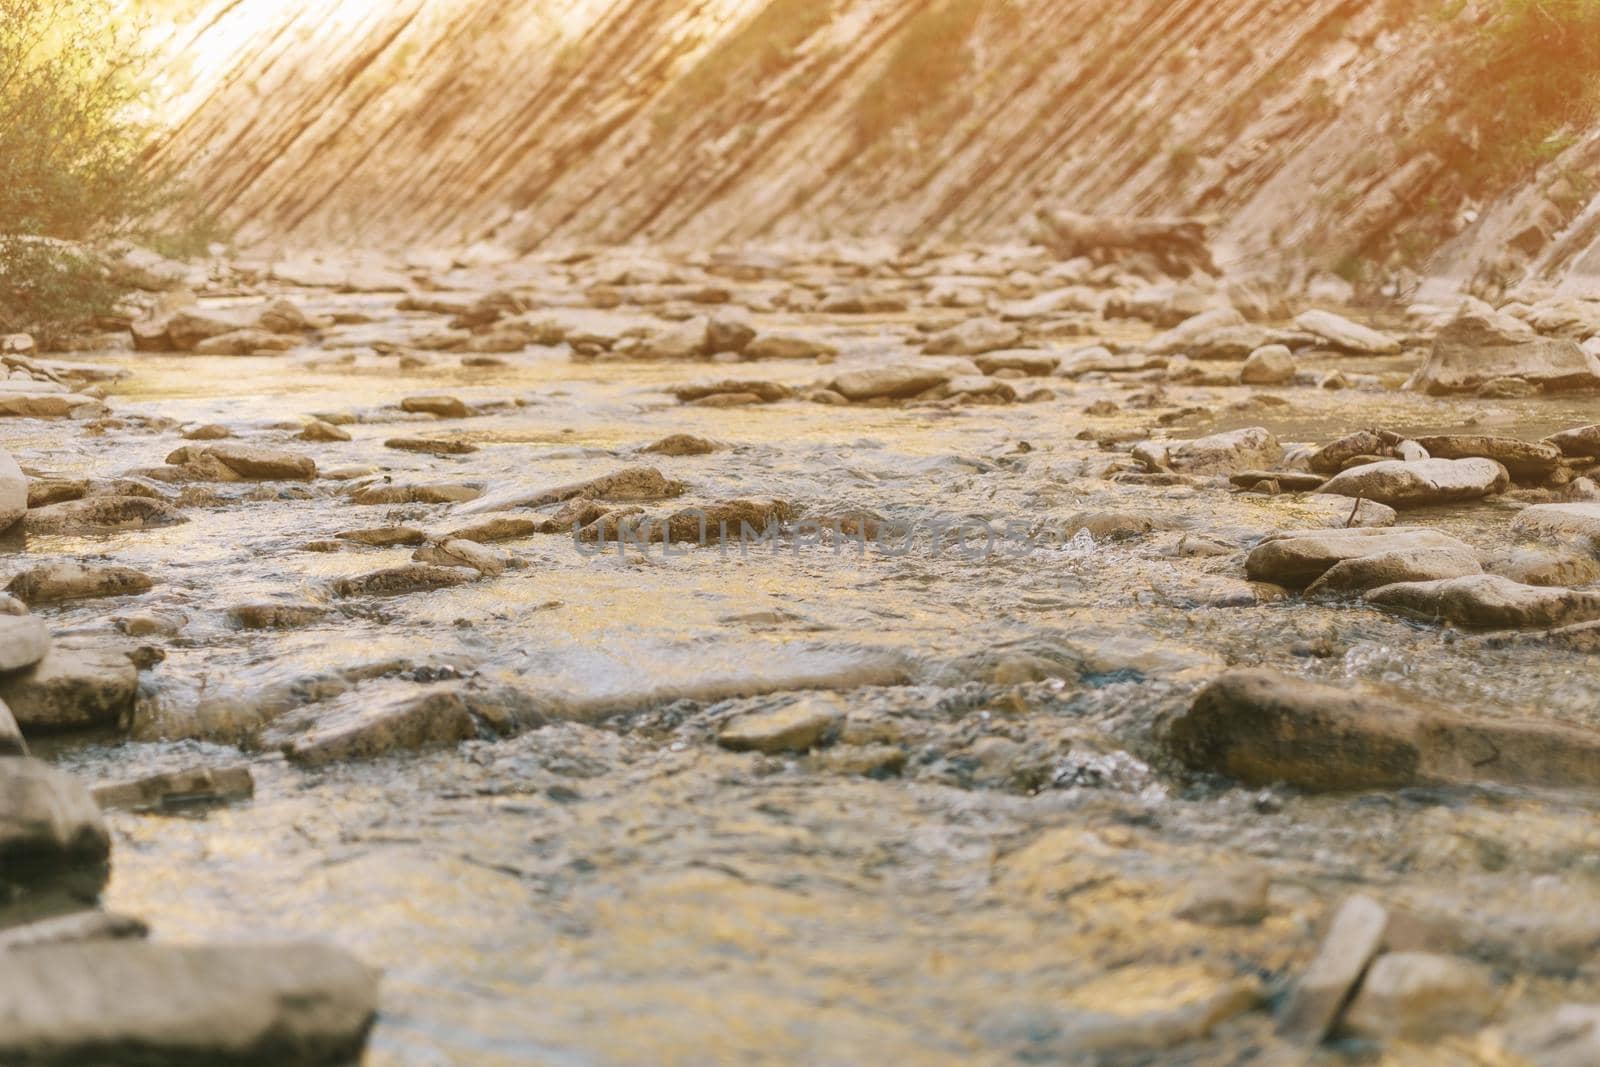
[0,246,1600,1064]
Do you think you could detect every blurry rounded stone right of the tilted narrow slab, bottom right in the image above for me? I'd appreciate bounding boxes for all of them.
[1344,952,1499,1041]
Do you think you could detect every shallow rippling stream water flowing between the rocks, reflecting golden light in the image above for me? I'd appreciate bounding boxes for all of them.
[12,262,1600,1065]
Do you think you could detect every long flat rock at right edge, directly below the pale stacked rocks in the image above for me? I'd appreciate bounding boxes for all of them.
[1366,574,1600,630]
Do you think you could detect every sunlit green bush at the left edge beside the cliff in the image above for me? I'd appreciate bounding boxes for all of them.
[0,0,176,344]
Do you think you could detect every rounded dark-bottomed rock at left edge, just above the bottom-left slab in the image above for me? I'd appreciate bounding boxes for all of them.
[0,757,110,883]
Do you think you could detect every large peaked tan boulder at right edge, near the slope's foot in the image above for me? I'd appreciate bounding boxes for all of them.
[1406,306,1600,397]
